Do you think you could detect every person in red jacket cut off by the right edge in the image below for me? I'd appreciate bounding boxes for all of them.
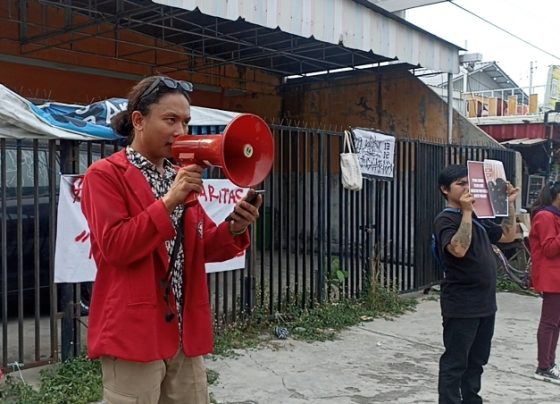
[529,182,560,384]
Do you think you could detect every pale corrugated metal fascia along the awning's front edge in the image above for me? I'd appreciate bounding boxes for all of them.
[153,0,461,73]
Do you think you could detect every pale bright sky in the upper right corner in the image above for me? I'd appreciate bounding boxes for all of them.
[406,0,560,93]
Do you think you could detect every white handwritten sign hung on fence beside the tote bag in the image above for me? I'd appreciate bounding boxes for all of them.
[352,129,395,179]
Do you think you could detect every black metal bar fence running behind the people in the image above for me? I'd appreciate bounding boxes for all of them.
[0,125,516,370]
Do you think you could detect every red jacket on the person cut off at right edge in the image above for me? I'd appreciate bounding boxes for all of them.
[529,210,560,293]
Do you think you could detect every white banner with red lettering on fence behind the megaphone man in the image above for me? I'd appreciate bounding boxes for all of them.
[54,175,248,283]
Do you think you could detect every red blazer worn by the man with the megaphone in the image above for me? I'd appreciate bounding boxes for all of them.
[82,150,249,362]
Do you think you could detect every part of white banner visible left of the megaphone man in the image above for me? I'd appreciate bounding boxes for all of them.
[54,175,97,283]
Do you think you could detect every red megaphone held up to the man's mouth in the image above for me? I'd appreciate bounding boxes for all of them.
[171,114,274,205]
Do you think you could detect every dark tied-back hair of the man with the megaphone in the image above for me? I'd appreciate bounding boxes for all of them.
[111,76,192,144]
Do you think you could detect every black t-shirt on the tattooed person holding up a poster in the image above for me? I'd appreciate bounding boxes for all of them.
[434,211,502,318]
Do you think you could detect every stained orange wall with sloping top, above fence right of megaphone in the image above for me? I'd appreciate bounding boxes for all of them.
[282,68,492,143]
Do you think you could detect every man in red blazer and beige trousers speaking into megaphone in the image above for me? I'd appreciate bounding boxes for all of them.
[82,76,262,404]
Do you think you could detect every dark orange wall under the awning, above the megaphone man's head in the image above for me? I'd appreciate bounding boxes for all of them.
[0,0,281,118]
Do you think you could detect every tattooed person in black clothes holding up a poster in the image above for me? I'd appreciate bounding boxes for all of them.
[434,165,519,404]
